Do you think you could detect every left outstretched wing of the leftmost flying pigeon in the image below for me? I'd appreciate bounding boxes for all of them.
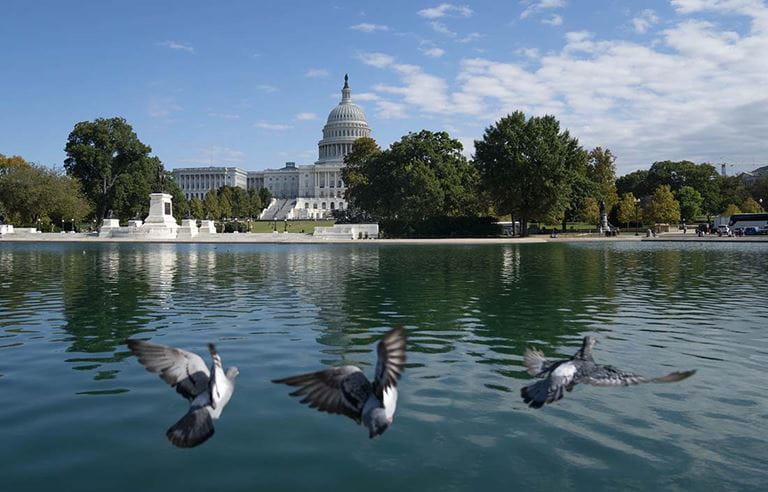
[127,340,210,400]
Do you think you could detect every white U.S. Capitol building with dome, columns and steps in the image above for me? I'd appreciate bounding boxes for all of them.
[173,75,371,220]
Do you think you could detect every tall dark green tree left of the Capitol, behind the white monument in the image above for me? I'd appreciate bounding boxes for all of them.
[64,118,162,218]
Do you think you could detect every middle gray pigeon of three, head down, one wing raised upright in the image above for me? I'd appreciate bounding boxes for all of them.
[272,327,406,438]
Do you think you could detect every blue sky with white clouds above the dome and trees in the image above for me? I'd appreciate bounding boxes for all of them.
[0,0,768,175]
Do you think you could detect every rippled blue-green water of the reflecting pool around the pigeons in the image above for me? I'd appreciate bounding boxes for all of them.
[0,243,768,492]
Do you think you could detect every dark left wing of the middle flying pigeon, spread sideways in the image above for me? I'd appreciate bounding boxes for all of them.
[272,366,372,423]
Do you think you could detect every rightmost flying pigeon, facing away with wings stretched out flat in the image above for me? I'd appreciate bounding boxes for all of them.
[520,337,696,408]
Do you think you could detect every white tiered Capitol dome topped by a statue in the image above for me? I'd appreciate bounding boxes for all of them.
[318,75,371,162]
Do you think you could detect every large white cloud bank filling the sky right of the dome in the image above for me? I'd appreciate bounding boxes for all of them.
[356,0,768,172]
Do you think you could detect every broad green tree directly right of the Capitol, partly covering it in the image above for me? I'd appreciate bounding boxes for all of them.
[342,130,479,223]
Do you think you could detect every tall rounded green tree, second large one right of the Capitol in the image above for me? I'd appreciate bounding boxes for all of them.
[475,111,587,235]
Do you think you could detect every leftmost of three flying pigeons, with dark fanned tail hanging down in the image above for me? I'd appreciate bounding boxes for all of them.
[127,340,239,448]
